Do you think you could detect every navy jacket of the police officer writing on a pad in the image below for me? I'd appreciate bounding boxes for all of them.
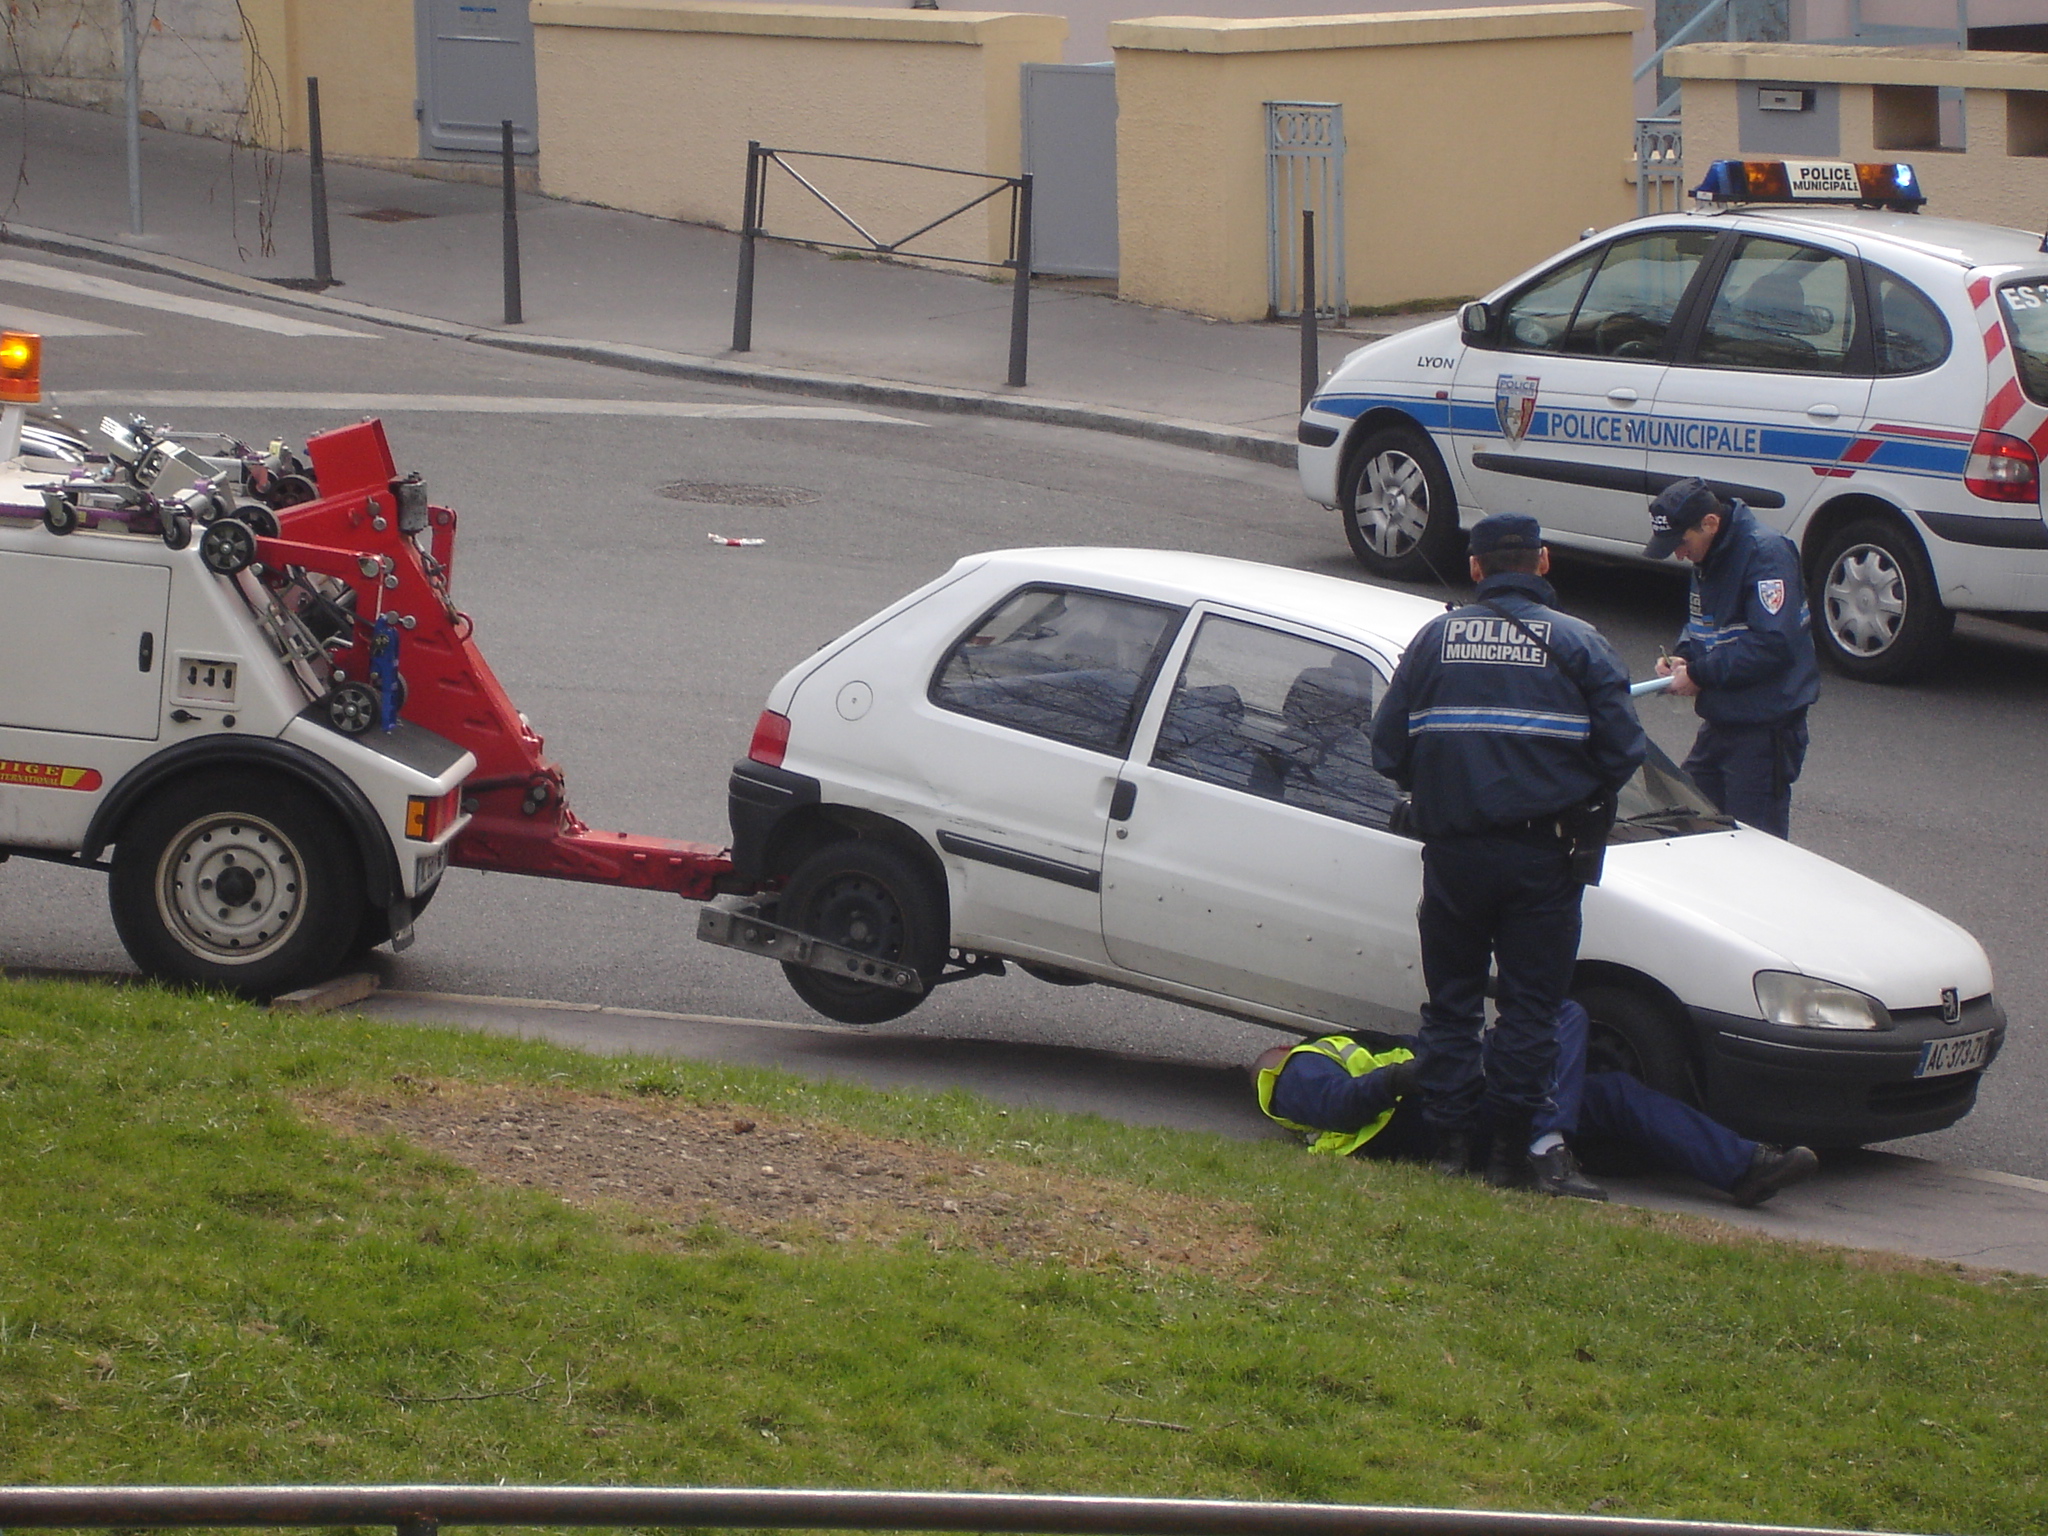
[1677,502,1821,725]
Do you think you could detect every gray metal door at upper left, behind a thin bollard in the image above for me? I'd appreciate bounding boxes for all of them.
[412,0,541,160]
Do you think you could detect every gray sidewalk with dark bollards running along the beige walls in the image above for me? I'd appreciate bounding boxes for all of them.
[0,98,1427,465]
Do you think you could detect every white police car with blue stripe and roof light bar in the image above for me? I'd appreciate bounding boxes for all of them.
[1298,160,2048,680]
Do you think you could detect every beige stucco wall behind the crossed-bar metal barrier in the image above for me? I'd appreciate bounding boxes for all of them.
[532,0,1067,260]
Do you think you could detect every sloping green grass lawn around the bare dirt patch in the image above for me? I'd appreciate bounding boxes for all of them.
[0,981,2048,1532]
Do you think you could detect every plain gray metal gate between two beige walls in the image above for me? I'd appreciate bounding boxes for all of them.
[1022,63,1116,276]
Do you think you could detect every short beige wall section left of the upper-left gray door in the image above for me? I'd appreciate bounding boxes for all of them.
[242,0,420,160]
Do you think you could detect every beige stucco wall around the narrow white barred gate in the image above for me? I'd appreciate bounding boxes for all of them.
[1110,4,1640,319]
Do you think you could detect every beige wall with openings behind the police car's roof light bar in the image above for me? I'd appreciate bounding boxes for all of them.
[1665,41,2048,229]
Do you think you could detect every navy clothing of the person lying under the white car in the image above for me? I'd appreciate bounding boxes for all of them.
[1272,1001,1757,1190]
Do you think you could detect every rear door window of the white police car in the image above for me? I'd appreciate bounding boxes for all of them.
[1696,236,1855,373]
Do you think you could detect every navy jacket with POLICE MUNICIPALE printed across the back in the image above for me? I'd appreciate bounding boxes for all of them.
[1372,571,1647,838]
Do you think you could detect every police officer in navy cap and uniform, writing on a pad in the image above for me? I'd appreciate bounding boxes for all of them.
[1642,477,1821,838]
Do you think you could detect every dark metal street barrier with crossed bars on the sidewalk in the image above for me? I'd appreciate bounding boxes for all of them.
[733,139,1030,385]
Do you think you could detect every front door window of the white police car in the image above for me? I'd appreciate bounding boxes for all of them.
[1501,229,1714,358]
